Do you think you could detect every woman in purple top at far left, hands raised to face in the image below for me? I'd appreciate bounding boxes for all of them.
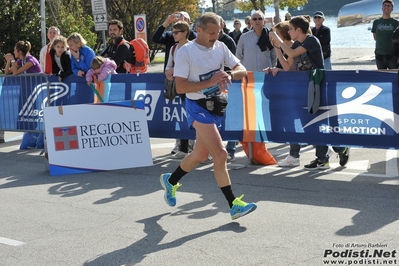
[4,41,42,75]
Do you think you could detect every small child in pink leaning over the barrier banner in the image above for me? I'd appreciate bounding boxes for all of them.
[86,56,117,86]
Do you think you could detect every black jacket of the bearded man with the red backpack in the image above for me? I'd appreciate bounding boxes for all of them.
[100,36,135,73]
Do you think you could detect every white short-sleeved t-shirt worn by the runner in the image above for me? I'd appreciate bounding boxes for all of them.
[173,40,240,100]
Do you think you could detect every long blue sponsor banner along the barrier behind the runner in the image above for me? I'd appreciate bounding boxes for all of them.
[0,71,399,149]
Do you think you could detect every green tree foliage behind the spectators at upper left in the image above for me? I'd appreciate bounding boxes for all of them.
[0,0,200,68]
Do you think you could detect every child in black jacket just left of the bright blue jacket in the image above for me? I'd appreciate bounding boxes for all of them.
[50,35,72,81]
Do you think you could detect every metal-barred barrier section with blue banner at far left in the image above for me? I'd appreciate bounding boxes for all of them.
[0,74,50,133]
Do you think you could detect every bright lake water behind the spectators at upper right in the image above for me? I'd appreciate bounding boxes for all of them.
[226,17,375,48]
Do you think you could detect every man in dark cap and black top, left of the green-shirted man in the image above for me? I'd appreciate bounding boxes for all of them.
[312,11,332,70]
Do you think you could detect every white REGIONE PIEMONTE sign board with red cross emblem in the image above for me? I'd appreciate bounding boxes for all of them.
[44,101,153,175]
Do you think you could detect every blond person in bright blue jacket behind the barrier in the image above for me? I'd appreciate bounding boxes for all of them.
[67,32,95,77]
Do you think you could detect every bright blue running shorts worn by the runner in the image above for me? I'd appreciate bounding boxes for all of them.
[185,98,223,129]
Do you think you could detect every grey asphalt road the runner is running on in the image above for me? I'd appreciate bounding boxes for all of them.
[0,48,399,266]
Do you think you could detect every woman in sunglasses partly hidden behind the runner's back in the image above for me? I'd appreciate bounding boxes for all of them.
[165,21,190,158]
